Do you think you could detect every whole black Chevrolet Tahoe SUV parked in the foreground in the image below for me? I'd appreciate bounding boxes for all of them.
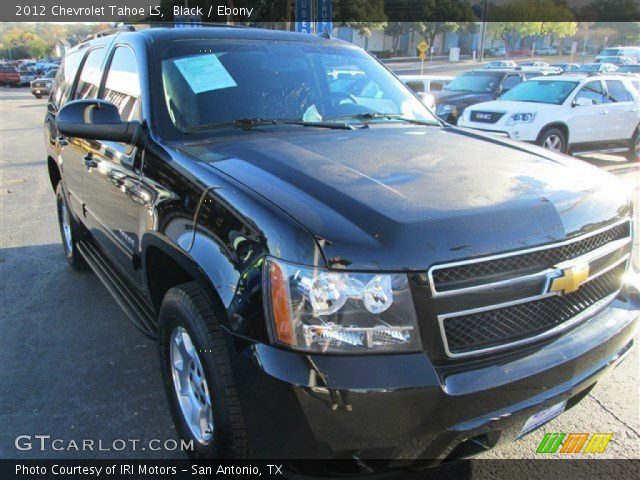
[45,27,639,465]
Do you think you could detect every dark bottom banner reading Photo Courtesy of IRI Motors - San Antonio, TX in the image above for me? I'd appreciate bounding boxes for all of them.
[0,459,640,480]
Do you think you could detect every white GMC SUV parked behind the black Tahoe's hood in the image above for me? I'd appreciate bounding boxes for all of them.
[458,74,640,160]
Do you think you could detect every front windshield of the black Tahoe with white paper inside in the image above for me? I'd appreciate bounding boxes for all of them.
[159,40,437,132]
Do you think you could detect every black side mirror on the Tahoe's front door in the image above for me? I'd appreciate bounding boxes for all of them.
[56,99,140,144]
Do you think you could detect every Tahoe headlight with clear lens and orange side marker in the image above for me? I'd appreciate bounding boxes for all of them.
[264,258,421,353]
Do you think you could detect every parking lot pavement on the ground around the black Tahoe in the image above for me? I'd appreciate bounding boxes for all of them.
[0,88,640,472]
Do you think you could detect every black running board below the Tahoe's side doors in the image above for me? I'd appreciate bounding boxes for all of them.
[76,240,158,340]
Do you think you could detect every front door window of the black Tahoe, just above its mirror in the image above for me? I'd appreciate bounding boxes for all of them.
[103,47,140,121]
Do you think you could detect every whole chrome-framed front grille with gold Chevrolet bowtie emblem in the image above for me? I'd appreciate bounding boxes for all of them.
[428,219,632,358]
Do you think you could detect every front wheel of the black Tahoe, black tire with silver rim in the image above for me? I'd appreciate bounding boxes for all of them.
[158,283,247,459]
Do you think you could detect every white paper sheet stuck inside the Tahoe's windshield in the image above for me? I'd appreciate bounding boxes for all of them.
[173,53,238,93]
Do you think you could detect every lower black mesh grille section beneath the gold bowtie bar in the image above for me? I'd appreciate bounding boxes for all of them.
[443,264,625,354]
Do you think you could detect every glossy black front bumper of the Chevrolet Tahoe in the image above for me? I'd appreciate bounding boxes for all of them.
[233,284,640,465]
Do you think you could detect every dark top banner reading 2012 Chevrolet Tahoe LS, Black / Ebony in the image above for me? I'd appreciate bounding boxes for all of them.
[0,0,640,26]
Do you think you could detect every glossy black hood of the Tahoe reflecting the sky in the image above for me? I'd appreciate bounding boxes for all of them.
[177,124,629,270]
